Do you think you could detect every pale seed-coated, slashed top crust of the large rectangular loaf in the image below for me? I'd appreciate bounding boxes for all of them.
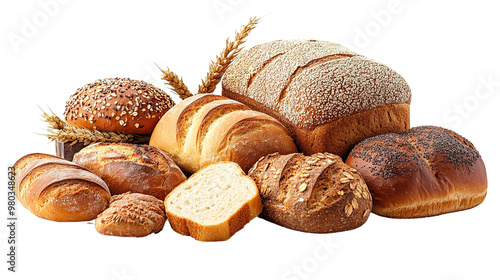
[222,40,411,129]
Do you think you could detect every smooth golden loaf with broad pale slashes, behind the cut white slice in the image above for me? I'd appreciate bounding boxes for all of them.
[149,94,297,173]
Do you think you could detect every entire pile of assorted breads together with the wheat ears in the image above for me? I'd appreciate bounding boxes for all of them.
[14,34,487,241]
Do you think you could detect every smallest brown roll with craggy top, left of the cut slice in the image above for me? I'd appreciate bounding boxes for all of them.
[95,192,167,237]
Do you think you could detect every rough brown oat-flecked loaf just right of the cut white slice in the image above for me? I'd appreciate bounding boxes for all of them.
[248,153,372,233]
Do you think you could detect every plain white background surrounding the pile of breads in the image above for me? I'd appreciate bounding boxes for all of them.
[0,0,500,280]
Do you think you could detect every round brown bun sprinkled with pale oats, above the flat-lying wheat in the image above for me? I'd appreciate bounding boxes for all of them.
[64,78,175,134]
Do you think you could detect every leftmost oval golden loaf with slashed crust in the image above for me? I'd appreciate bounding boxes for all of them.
[14,153,110,222]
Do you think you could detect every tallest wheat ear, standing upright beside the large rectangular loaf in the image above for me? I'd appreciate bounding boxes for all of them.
[198,17,260,93]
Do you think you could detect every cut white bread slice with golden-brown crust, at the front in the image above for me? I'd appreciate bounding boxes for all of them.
[165,162,262,241]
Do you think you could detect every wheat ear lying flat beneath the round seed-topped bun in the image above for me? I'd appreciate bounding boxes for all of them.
[42,110,150,145]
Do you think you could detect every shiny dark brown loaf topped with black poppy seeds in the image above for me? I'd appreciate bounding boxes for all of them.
[346,126,487,218]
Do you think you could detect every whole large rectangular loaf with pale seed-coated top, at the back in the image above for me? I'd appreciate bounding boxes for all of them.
[222,40,411,158]
